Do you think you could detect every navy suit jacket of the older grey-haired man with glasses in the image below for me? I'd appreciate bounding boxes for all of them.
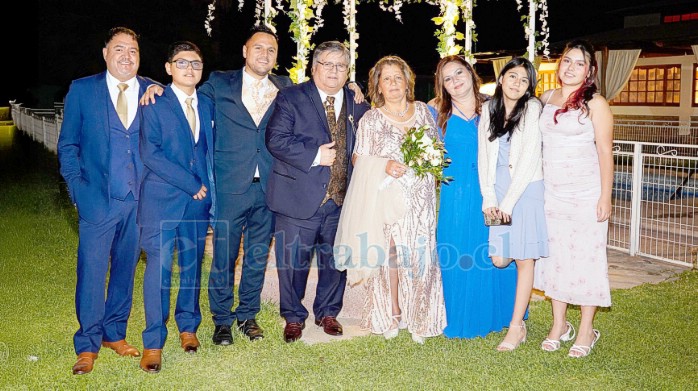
[266,81,370,219]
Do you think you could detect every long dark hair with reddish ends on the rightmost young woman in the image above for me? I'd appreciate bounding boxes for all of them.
[553,39,599,123]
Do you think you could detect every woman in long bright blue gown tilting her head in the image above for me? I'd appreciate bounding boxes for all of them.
[429,56,516,338]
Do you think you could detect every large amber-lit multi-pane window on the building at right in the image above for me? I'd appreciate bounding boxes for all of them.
[612,65,681,106]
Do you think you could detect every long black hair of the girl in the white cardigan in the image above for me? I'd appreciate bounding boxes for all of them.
[489,57,537,141]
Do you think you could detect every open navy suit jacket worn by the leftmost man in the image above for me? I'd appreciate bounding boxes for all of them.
[58,71,154,223]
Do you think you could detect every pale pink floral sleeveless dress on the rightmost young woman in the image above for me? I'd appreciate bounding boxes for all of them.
[534,104,611,307]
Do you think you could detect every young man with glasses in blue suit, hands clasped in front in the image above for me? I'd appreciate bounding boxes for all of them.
[138,41,215,373]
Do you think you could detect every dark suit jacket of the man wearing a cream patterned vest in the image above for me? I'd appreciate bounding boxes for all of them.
[198,69,292,194]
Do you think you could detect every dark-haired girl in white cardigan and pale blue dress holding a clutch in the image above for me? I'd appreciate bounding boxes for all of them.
[478,57,548,351]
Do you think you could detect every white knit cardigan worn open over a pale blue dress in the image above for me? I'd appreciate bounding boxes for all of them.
[477,98,543,215]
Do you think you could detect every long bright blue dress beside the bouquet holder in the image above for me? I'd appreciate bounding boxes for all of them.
[430,107,516,338]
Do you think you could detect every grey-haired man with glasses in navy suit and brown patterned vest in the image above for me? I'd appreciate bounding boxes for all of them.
[266,41,369,342]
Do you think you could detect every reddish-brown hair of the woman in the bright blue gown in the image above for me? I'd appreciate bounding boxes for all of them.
[434,55,485,134]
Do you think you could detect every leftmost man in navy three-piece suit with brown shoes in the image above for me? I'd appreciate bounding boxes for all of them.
[58,27,158,374]
